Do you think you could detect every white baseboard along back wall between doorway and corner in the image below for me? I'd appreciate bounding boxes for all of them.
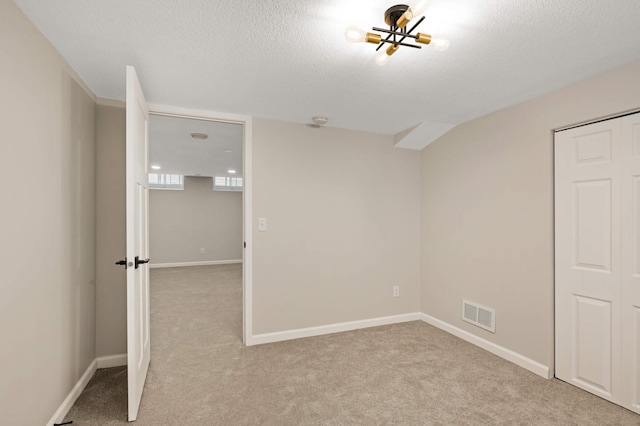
[246,312,420,346]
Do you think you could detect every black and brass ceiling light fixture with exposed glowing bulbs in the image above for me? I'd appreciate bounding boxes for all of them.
[344,0,450,65]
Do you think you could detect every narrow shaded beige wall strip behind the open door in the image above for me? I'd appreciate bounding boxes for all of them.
[96,105,127,356]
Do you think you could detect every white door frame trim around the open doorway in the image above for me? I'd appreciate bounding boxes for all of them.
[149,104,254,346]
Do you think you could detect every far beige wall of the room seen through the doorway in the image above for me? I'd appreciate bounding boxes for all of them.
[149,177,242,264]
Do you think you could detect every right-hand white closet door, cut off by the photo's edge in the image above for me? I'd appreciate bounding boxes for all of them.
[620,110,640,413]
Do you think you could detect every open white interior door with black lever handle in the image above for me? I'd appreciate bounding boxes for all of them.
[126,67,151,421]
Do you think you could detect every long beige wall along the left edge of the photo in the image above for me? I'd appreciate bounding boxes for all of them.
[0,1,96,425]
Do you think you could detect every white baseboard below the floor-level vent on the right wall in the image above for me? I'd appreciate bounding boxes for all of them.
[419,313,551,379]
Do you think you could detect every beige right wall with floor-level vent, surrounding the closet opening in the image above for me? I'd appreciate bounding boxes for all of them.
[421,62,640,366]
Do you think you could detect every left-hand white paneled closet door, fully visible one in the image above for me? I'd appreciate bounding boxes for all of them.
[555,120,622,404]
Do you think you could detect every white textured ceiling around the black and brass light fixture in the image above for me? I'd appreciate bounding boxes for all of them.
[15,0,640,148]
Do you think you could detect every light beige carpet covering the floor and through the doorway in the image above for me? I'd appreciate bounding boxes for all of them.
[66,265,640,426]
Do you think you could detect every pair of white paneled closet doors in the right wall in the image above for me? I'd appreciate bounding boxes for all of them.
[555,114,640,413]
